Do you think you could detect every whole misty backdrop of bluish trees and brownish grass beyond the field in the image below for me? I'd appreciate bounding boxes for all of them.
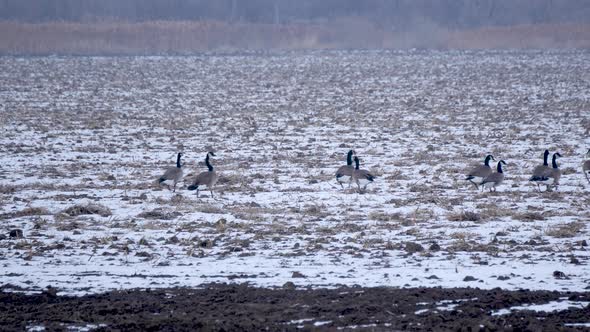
[0,0,590,54]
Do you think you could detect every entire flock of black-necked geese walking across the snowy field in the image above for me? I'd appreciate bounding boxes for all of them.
[158,149,590,197]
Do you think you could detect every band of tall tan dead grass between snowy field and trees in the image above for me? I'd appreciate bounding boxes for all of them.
[0,17,590,55]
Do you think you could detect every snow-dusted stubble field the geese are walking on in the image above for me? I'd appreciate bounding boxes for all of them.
[0,51,590,294]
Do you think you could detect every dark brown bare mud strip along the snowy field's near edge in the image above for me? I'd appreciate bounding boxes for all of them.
[0,284,590,331]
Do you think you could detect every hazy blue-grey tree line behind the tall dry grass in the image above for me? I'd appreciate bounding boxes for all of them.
[0,0,590,30]
